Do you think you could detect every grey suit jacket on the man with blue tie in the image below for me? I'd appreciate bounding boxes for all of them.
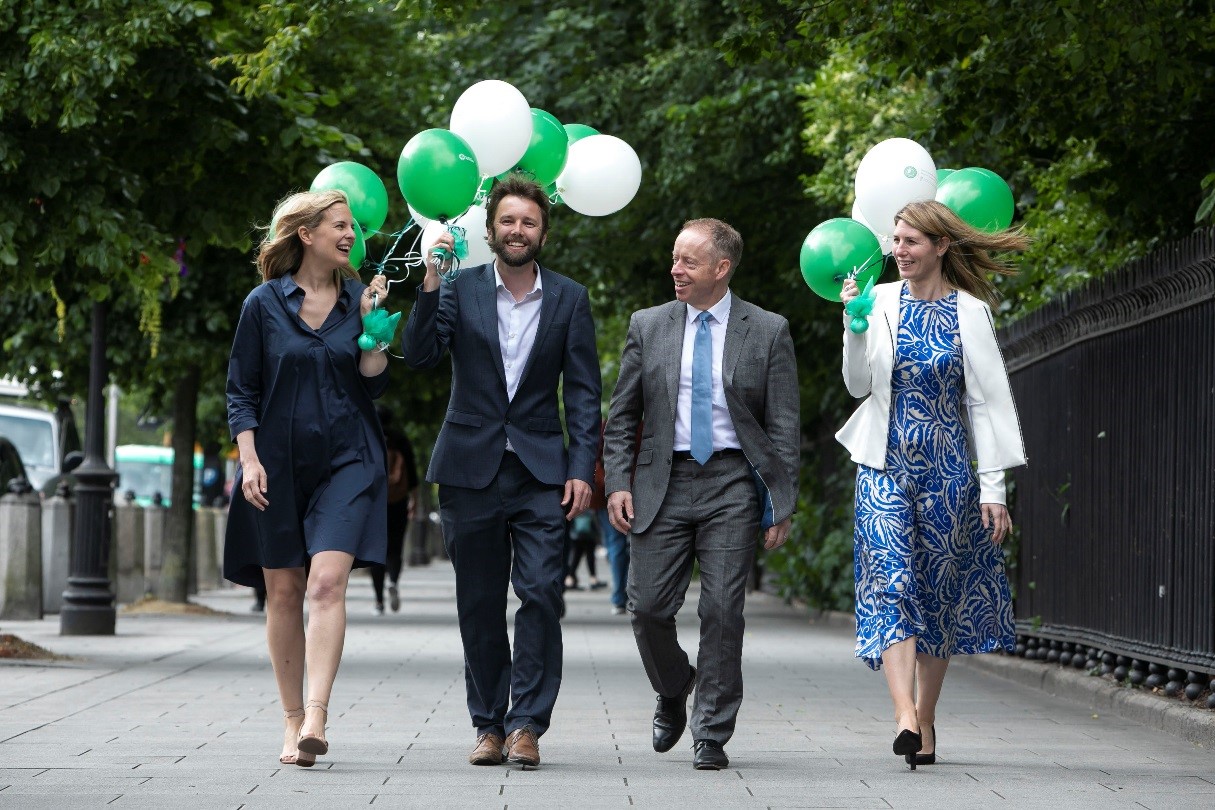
[604,295,801,532]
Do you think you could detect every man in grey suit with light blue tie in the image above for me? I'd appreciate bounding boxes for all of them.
[604,219,801,770]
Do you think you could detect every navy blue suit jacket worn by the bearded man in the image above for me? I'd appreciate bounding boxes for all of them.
[402,264,601,489]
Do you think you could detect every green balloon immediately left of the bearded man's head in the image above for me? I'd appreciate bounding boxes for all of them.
[396,129,481,220]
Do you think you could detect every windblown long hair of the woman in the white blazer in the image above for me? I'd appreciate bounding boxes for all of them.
[894,199,1029,306]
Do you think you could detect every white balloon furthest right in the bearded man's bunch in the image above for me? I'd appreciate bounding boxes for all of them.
[556,135,642,216]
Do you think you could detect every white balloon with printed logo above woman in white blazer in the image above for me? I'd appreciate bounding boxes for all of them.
[853,137,937,237]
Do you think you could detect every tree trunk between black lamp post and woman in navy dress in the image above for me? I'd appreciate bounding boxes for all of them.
[157,364,198,602]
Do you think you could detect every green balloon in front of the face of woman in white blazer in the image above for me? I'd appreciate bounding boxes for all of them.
[799,217,882,304]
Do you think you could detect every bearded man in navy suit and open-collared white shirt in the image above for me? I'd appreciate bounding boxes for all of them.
[402,177,601,766]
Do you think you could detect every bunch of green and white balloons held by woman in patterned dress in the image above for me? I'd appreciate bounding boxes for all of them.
[801,137,1015,315]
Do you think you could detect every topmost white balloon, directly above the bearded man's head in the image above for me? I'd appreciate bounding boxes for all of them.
[448,79,532,175]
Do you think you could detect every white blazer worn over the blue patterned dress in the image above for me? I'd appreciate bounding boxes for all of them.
[836,282,1027,504]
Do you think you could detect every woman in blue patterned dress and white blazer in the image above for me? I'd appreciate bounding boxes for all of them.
[836,200,1027,770]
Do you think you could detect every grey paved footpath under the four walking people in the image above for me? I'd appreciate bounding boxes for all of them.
[0,562,1215,810]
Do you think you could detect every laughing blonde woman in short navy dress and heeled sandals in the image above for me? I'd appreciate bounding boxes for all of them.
[224,192,388,766]
